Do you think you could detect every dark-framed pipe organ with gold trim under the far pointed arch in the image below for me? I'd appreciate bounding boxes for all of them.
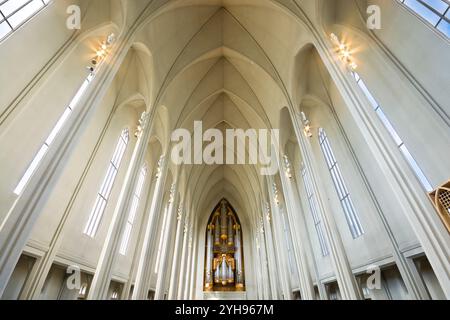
[204,200,245,291]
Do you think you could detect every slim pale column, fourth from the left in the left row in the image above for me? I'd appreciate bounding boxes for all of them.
[155,182,177,300]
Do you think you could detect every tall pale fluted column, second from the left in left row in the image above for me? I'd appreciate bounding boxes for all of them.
[88,112,153,300]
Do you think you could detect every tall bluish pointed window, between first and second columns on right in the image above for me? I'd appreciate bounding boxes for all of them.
[319,128,364,239]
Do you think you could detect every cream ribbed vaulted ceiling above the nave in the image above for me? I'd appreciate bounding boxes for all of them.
[93,0,360,228]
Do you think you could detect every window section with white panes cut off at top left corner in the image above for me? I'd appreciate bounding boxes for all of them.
[0,0,50,40]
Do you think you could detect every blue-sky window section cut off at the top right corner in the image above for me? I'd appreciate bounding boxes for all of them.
[398,0,450,38]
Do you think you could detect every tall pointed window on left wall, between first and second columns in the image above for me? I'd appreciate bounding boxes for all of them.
[84,129,130,237]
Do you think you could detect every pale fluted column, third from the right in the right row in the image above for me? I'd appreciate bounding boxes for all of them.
[277,155,315,300]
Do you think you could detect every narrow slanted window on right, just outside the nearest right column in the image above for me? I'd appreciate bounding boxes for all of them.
[352,72,434,192]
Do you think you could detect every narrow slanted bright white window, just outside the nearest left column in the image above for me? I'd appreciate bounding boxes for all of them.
[13,73,94,195]
